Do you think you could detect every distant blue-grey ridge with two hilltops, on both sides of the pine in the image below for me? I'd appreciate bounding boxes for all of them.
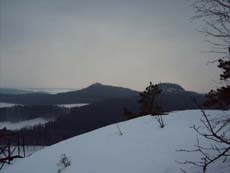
[0,83,205,111]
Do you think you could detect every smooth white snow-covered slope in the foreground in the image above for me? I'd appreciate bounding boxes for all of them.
[3,110,230,173]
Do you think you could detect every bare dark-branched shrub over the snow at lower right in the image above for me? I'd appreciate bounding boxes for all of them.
[178,110,230,173]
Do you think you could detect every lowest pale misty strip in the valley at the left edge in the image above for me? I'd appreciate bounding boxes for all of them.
[0,118,51,130]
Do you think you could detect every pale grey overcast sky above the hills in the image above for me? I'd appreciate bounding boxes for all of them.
[0,0,223,92]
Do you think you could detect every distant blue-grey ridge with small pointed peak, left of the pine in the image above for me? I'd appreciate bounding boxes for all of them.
[0,83,138,105]
